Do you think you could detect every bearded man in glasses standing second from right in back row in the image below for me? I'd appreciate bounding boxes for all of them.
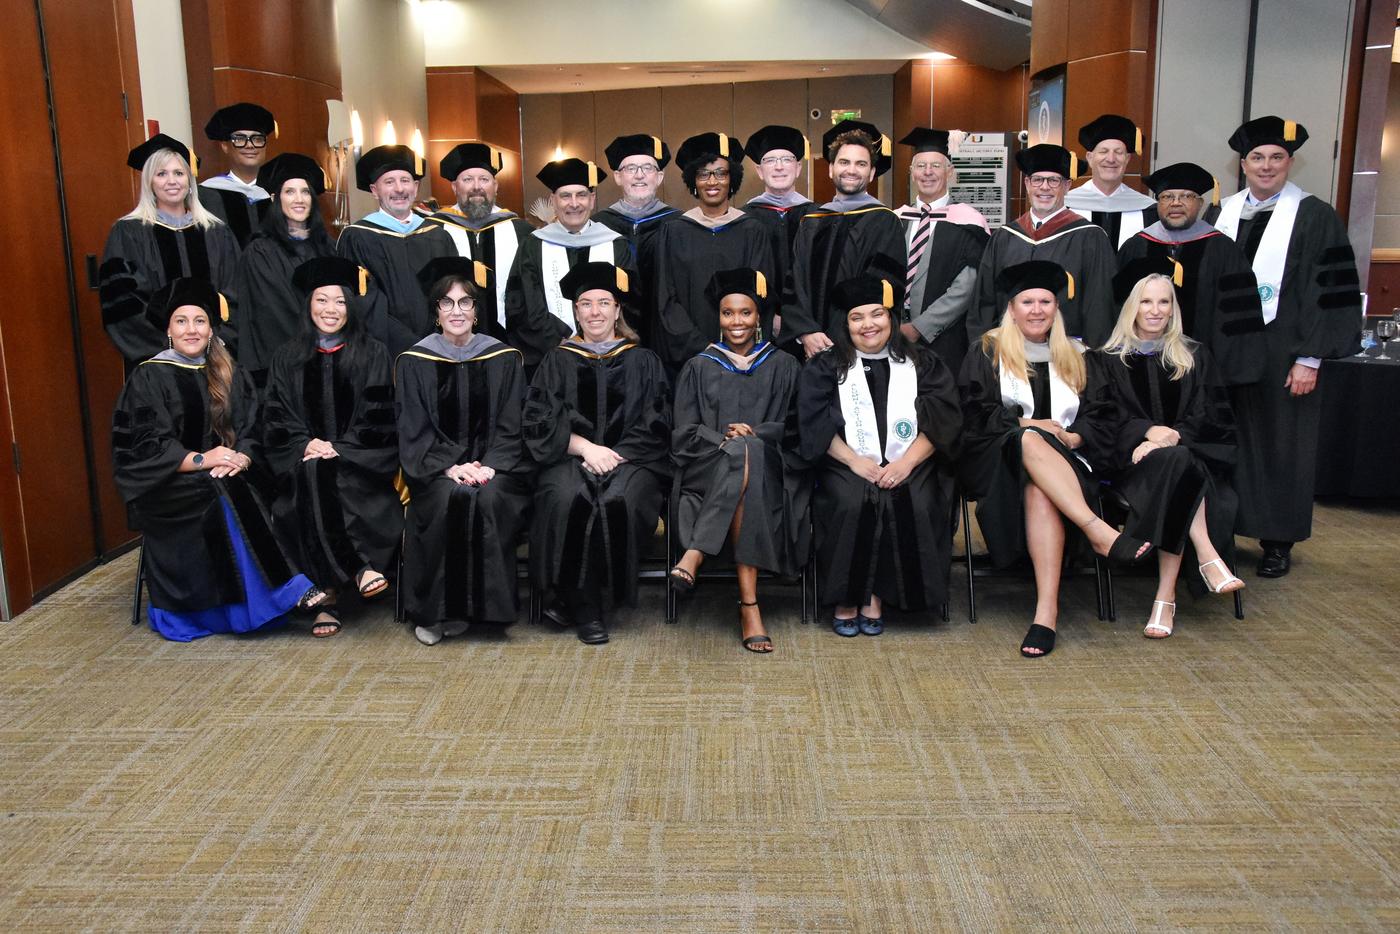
[1119,162,1264,385]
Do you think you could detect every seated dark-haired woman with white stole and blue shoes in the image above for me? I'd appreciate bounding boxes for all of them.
[798,274,962,636]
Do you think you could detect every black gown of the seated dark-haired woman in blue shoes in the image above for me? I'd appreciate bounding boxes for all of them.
[798,351,962,611]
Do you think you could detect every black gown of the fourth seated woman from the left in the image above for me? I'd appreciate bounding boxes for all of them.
[525,340,671,605]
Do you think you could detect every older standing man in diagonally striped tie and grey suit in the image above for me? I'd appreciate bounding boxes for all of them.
[897,126,987,372]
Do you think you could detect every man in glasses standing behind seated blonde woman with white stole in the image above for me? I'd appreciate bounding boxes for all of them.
[967,143,1119,347]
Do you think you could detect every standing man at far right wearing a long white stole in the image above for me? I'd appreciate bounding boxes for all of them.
[1215,116,1361,577]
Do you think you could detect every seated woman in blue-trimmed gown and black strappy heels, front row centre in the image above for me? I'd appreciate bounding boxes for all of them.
[671,269,811,653]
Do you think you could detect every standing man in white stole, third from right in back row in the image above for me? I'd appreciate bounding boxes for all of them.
[1064,113,1156,249]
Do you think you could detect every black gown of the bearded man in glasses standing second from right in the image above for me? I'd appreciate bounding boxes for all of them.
[1119,231,1266,386]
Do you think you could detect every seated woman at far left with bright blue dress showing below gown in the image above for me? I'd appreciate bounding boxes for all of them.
[112,279,326,643]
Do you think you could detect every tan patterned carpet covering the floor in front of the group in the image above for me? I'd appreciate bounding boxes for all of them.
[0,506,1400,931]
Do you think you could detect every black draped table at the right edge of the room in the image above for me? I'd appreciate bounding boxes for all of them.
[1317,352,1400,499]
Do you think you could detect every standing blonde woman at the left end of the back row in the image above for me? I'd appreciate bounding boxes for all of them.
[98,133,238,371]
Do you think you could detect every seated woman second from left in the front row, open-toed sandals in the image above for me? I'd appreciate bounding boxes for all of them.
[263,256,403,636]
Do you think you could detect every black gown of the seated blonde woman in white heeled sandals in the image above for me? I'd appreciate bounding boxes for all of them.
[1095,346,1238,571]
